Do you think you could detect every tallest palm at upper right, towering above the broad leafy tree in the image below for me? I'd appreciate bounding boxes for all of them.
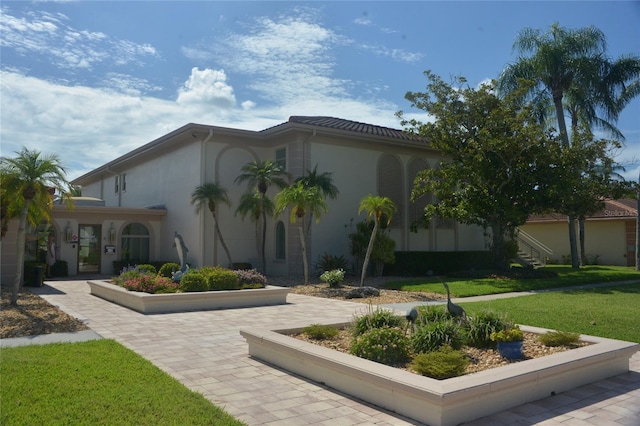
[498,23,624,268]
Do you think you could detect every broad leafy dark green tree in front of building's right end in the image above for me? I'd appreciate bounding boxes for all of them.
[398,71,559,269]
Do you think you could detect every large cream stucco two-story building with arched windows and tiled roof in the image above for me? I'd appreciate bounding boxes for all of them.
[2,116,486,280]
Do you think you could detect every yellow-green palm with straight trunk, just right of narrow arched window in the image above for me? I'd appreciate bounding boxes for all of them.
[275,182,327,285]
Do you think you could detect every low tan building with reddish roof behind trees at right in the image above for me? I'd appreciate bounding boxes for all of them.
[520,199,638,266]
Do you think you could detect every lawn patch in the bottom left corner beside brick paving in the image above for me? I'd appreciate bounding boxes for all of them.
[0,340,244,426]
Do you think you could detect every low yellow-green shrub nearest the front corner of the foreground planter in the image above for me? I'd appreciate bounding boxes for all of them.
[410,346,469,380]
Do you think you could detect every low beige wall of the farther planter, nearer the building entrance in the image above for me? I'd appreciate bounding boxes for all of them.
[87,281,289,314]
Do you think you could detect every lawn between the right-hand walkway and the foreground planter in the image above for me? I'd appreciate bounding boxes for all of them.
[460,282,640,343]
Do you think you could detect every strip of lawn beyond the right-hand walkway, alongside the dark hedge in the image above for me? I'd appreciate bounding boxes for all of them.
[385,265,640,297]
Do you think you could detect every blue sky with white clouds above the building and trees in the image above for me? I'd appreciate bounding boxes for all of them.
[0,1,640,180]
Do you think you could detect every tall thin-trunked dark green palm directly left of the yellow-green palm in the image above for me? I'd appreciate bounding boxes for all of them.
[235,160,287,275]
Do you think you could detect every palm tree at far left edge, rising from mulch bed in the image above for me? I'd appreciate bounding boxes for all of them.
[0,147,69,306]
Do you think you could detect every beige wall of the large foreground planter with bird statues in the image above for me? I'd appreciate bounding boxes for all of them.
[240,324,640,426]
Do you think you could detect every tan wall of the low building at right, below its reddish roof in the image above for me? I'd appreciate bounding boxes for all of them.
[521,220,628,266]
